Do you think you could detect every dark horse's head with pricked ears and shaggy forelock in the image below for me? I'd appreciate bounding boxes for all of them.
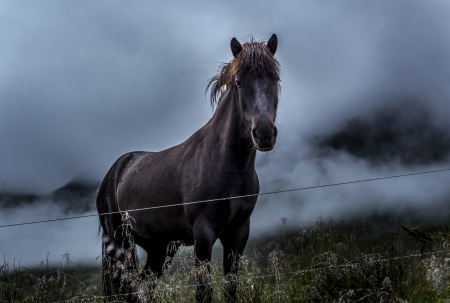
[208,34,280,151]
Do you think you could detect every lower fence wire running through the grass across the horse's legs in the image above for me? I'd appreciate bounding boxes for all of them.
[52,249,450,303]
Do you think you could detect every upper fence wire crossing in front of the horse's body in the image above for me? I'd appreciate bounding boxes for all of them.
[0,167,450,228]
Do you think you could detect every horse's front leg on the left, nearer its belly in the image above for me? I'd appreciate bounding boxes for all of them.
[194,221,217,303]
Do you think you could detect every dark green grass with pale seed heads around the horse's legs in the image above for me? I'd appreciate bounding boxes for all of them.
[0,219,450,303]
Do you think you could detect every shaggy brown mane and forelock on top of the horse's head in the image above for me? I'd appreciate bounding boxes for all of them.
[206,36,280,107]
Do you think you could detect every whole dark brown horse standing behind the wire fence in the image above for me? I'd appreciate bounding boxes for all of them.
[96,34,280,302]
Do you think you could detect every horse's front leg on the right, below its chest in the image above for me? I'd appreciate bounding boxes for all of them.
[220,219,250,302]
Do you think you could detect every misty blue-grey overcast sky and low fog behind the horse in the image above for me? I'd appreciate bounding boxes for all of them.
[0,0,450,266]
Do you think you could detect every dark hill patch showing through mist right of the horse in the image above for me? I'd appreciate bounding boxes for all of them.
[315,100,450,166]
